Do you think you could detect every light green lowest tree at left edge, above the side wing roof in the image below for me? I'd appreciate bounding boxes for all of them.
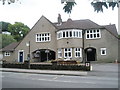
[0,34,16,48]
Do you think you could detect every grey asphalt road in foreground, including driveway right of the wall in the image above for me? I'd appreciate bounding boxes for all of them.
[1,64,118,88]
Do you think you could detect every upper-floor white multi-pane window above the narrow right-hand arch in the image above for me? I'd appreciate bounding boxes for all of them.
[86,29,101,39]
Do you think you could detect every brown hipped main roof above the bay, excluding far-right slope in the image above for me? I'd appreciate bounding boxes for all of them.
[55,19,103,30]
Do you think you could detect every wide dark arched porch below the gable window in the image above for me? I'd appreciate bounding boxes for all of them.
[33,49,55,62]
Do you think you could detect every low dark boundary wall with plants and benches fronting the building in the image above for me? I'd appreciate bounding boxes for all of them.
[2,60,90,71]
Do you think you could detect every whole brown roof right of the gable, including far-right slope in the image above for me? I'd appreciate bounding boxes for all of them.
[54,19,118,38]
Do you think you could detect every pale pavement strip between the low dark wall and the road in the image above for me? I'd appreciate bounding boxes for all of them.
[0,68,87,76]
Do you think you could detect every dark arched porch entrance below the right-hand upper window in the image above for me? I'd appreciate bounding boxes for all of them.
[85,47,97,61]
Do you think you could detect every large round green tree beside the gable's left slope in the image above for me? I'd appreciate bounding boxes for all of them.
[8,22,30,41]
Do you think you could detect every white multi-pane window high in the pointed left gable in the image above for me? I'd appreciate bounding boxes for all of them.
[36,33,51,42]
